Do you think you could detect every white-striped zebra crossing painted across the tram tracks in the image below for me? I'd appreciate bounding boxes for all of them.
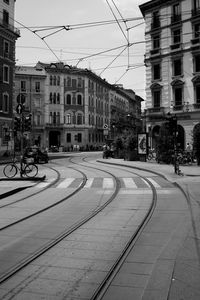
[35,176,173,190]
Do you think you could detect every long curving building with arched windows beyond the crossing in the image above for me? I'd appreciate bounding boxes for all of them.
[15,62,141,151]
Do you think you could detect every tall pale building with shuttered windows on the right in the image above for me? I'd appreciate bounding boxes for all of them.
[140,0,200,149]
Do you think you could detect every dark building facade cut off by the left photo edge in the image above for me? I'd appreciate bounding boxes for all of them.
[0,0,20,155]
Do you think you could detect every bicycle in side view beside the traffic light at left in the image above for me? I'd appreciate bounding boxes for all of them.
[3,159,38,178]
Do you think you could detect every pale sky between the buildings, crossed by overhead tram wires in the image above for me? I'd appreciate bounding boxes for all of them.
[15,0,147,99]
